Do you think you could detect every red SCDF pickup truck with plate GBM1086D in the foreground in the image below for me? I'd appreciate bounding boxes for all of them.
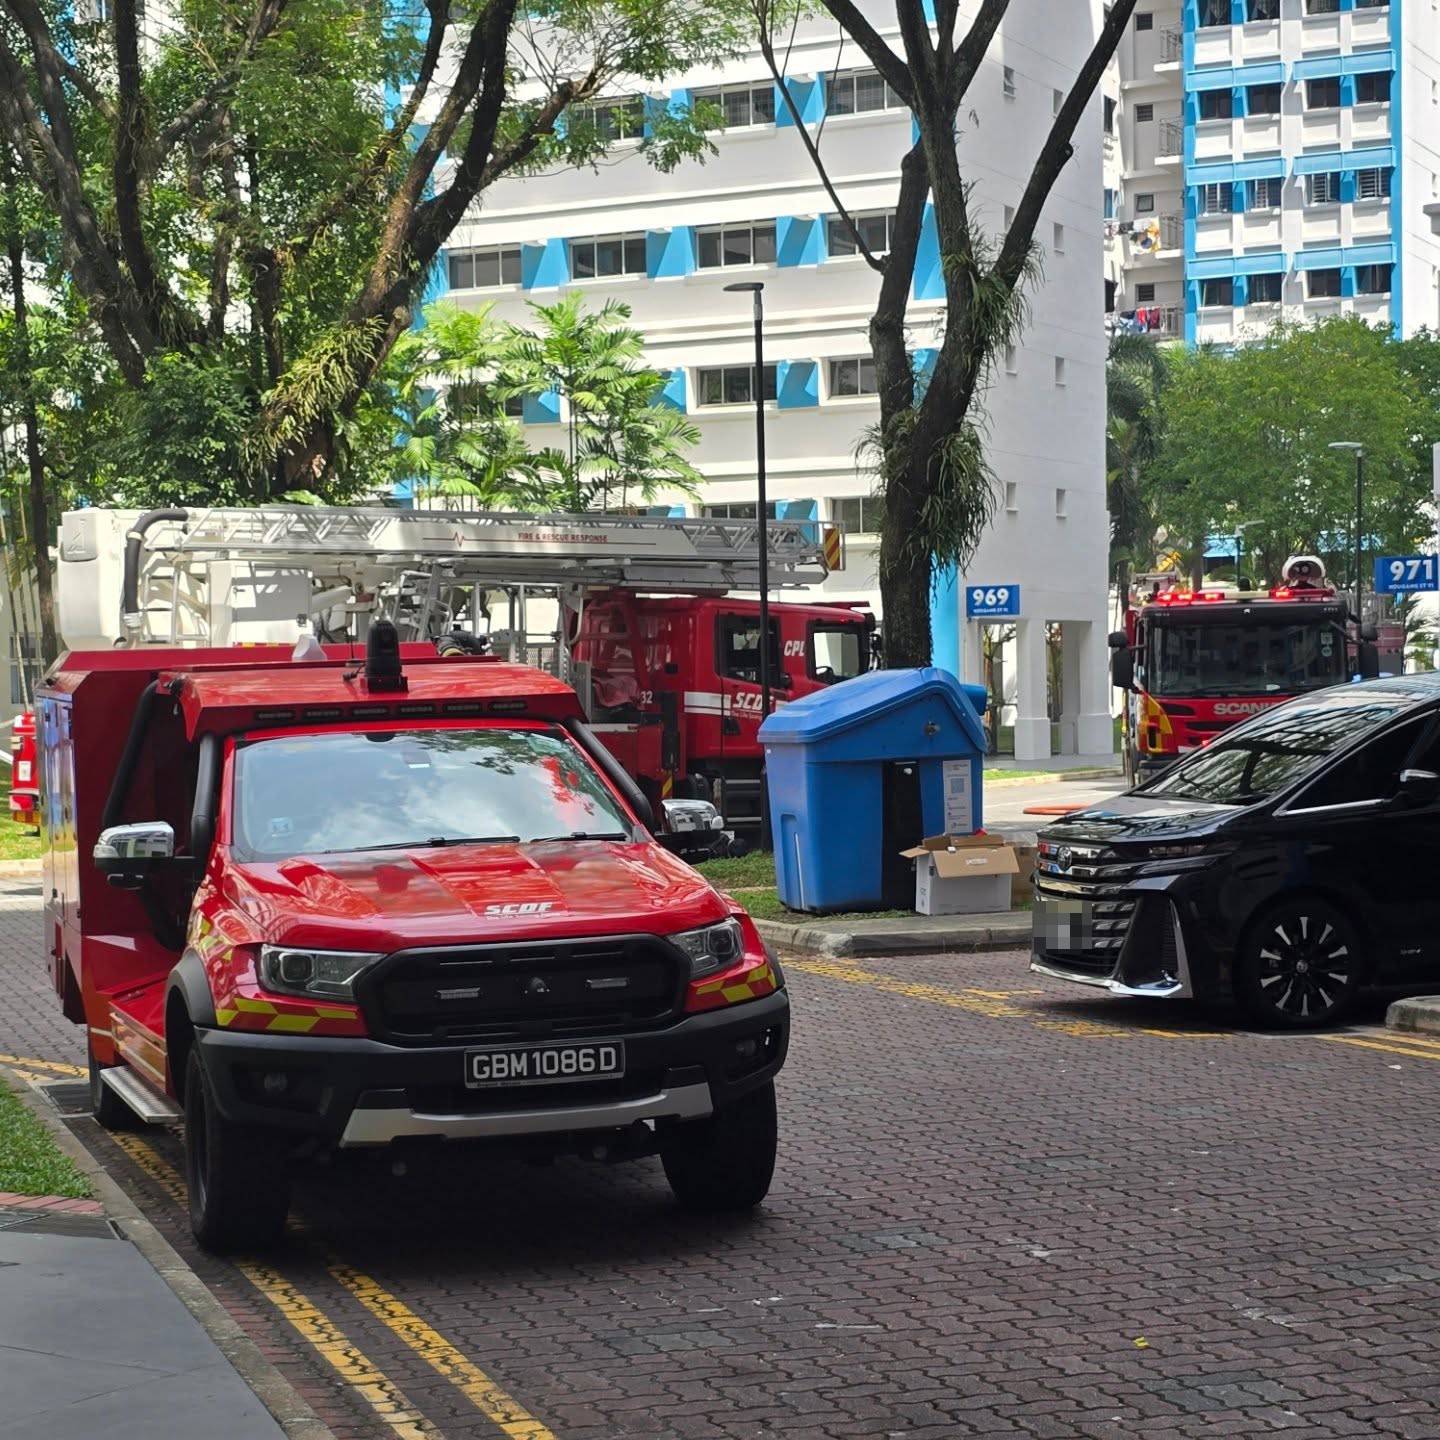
[39,619,789,1248]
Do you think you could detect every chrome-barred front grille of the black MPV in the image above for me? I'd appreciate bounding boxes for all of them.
[1035,840,1136,975]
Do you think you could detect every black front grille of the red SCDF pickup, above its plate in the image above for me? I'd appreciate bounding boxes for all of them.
[359,935,684,1044]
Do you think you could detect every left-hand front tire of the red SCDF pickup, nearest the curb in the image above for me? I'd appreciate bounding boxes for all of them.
[184,1047,289,1251]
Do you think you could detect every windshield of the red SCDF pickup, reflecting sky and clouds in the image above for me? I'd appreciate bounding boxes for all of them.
[233,729,632,860]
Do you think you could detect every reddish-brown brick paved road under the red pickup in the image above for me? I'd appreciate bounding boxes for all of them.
[0,881,1440,1440]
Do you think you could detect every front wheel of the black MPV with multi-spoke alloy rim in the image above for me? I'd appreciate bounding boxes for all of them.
[1236,896,1364,1030]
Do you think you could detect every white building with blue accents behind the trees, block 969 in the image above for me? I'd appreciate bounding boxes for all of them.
[426,0,1113,759]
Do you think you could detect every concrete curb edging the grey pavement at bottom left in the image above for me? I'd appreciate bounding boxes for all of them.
[12,1081,334,1440]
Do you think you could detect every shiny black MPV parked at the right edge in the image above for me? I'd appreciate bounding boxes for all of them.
[1031,674,1440,1028]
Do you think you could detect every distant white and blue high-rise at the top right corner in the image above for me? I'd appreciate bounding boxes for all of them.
[1110,0,1440,344]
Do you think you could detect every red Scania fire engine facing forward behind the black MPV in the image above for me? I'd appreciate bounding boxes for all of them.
[1110,556,1378,782]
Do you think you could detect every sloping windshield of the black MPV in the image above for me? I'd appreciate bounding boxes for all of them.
[1139,690,1405,805]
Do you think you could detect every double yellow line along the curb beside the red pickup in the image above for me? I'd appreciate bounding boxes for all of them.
[111,1132,556,1440]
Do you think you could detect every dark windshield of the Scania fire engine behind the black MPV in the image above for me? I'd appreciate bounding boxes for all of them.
[1145,621,1348,696]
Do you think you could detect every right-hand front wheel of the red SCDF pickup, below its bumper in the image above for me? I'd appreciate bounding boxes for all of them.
[660,1080,776,1210]
